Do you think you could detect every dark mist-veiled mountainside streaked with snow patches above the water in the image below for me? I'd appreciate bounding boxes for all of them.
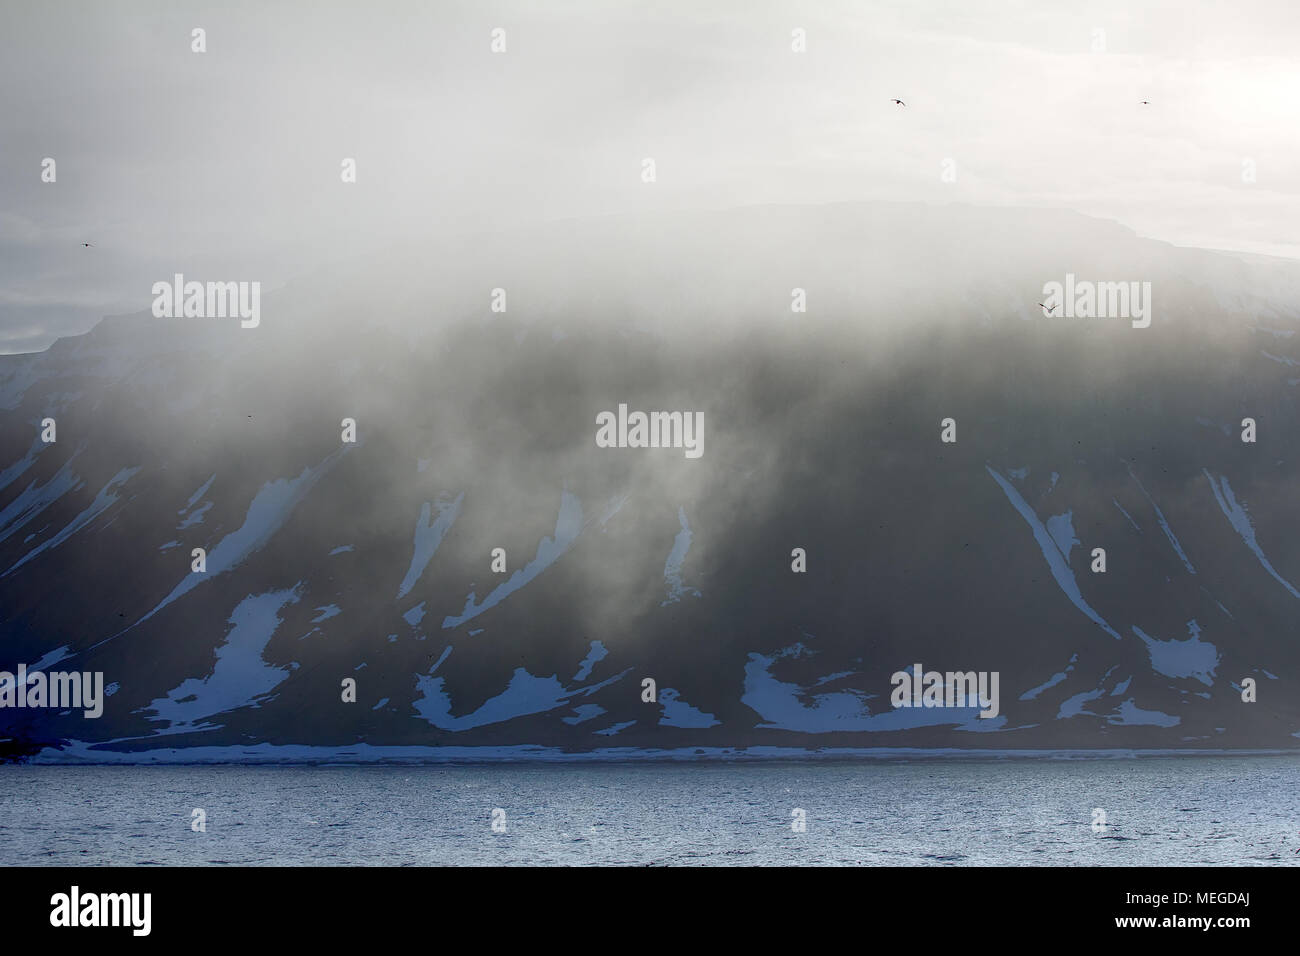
[0,204,1300,757]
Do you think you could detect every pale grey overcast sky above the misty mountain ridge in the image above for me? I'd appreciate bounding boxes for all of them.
[0,0,1300,352]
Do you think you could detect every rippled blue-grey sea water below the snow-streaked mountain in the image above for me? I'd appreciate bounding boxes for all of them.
[0,757,1300,866]
